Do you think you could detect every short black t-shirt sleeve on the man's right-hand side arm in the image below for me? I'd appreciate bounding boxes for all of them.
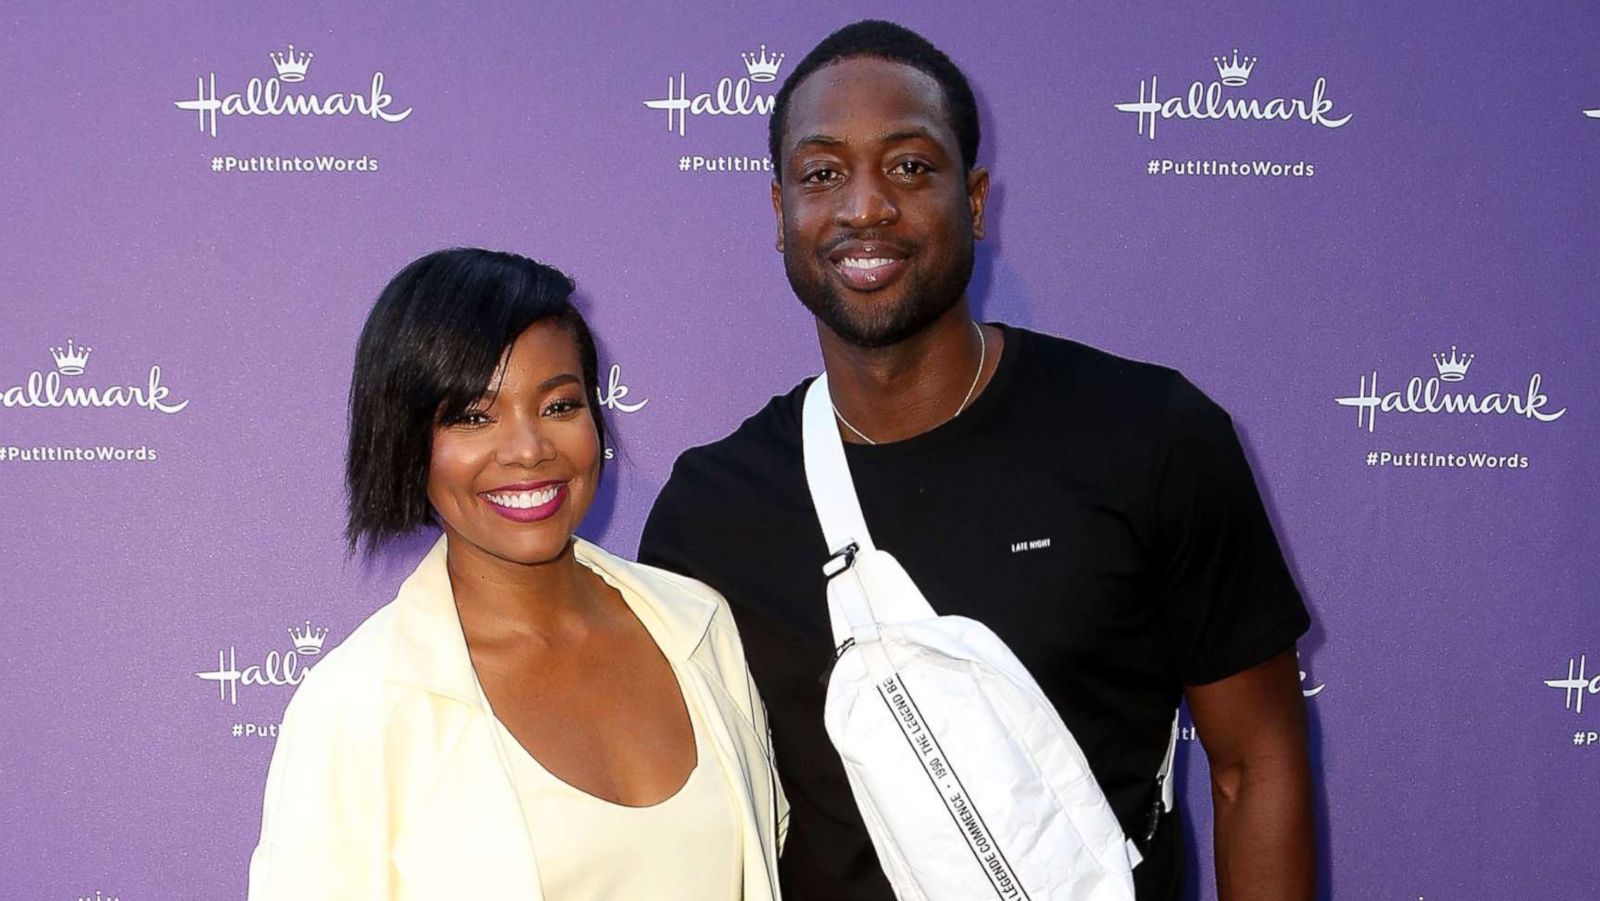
[1152,376,1310,685]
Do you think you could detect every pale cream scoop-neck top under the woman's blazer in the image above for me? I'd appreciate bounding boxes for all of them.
[478,667,744,901]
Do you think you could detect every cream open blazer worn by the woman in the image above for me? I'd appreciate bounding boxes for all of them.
[250,538,789,901]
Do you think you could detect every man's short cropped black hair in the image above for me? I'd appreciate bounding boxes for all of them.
[766,19,981,181]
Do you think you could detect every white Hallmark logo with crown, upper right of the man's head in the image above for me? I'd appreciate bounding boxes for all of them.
[1115,50,1352,141]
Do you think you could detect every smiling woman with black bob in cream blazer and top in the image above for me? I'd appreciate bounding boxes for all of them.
[250,250,786,901]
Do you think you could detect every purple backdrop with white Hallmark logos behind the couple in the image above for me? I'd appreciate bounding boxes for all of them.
[0,0,1600,901]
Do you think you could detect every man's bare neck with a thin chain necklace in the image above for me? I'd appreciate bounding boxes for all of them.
[818,299,1000,443]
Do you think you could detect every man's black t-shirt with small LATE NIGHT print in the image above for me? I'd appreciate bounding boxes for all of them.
[640,326,1309,901]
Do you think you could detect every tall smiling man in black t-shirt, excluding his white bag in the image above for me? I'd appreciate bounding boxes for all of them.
[640,21,1314,901]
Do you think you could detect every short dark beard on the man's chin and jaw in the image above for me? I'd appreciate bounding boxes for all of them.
[784,243,973,347]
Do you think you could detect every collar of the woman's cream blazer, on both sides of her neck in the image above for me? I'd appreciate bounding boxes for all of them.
[386,536,717,706]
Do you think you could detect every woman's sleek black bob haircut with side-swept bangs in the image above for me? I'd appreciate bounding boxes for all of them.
[344,248,605,552]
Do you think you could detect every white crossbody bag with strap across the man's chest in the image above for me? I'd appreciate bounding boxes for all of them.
[803,374,1176,901]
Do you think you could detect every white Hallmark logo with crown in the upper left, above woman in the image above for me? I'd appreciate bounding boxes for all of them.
[173,43,411,138]
